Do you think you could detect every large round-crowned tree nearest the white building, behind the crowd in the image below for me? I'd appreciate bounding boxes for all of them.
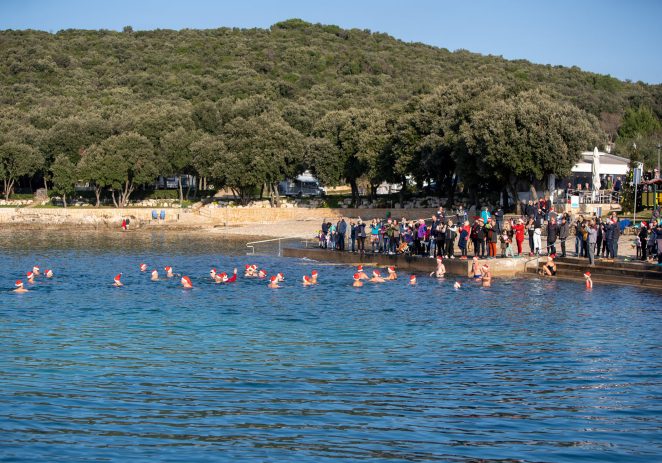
[461,91,603,206]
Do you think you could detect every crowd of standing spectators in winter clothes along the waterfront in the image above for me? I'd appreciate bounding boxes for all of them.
[318,199,662,265]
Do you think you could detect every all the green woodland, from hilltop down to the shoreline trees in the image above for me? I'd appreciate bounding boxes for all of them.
[0,19,662,205]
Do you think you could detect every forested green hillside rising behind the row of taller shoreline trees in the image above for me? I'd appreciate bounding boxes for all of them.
[0,19,662,123]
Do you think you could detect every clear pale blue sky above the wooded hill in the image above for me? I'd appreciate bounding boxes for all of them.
[0,0,662,84]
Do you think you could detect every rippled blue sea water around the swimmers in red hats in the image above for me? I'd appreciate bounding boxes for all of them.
[0,231,662,462]
